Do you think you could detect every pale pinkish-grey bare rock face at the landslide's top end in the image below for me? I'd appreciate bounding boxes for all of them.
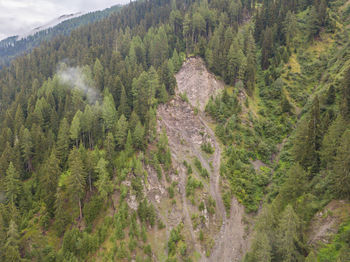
[176,58,224,111]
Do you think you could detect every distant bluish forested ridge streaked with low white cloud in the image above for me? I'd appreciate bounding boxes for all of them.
[0,5,121,68]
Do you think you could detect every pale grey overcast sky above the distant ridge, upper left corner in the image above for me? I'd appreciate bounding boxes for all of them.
[0,0,129,40]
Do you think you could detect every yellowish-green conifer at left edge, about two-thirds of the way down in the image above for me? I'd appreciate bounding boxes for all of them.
[5,162,21,204]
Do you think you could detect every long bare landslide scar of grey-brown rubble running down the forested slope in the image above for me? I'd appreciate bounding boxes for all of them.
[157,58,248,262]
